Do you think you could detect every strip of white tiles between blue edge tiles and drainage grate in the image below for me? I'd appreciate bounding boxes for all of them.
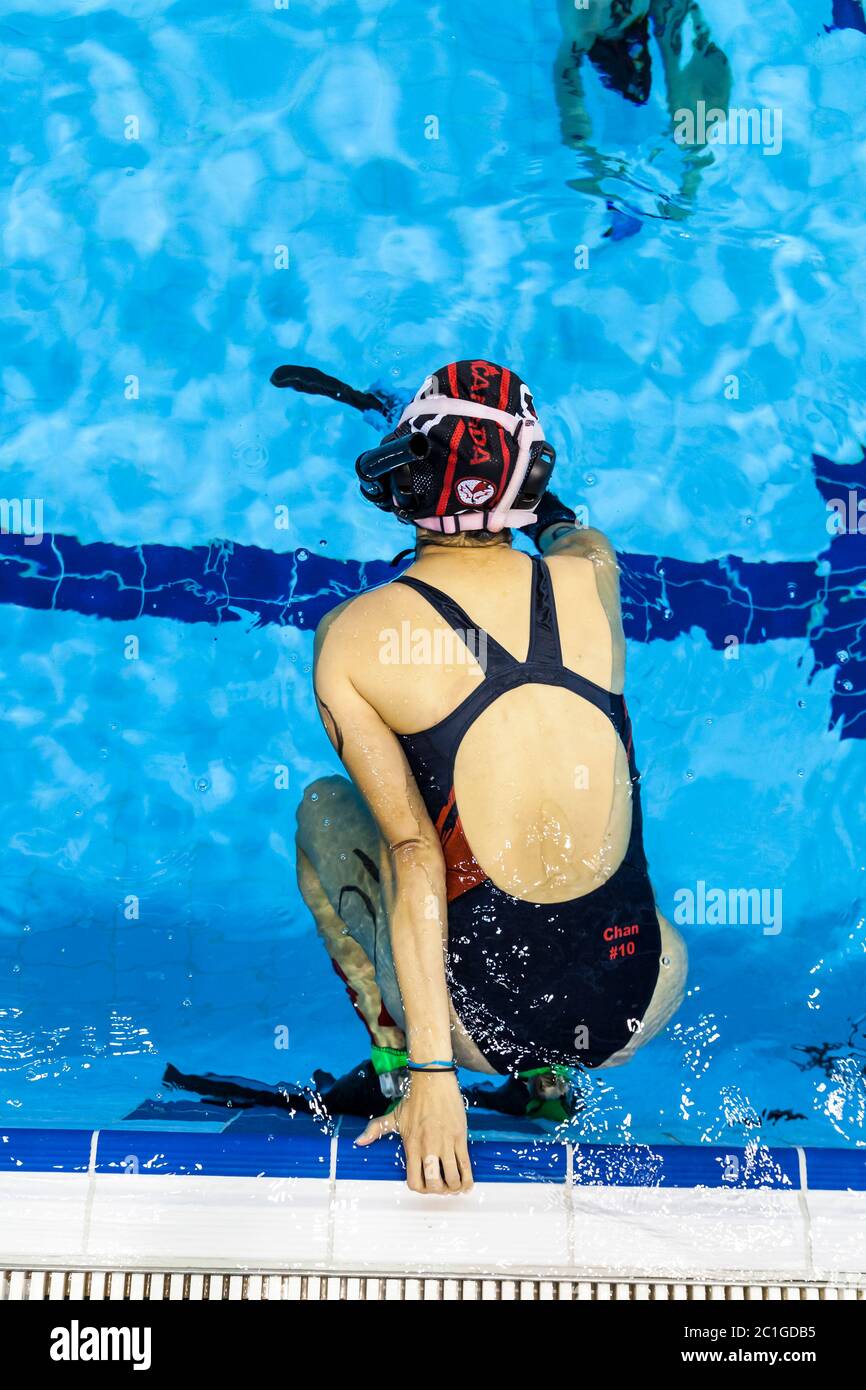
[0,1172,866,1280]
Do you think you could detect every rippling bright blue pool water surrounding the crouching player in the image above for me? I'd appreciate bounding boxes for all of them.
[0,0,866,1145]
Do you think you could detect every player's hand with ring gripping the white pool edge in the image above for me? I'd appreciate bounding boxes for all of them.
[356,1072,473,1194]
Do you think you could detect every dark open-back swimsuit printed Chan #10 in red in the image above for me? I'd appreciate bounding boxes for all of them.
[395,557,662,1072]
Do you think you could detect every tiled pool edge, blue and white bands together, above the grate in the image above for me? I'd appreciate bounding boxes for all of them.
[0,1111,866,1287]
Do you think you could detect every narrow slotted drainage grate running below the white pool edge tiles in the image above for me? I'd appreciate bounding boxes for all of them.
[0,1269,866,1302]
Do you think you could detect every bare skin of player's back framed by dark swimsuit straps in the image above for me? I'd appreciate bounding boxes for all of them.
[339,545,631,904]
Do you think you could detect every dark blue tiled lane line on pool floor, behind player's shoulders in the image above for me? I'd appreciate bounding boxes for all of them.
[0,453,866,738]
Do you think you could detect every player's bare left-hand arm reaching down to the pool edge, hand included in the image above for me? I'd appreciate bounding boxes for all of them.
[314,610,471,1193]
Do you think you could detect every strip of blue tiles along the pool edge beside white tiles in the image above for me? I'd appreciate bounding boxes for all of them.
[0,1115,866,1191]
